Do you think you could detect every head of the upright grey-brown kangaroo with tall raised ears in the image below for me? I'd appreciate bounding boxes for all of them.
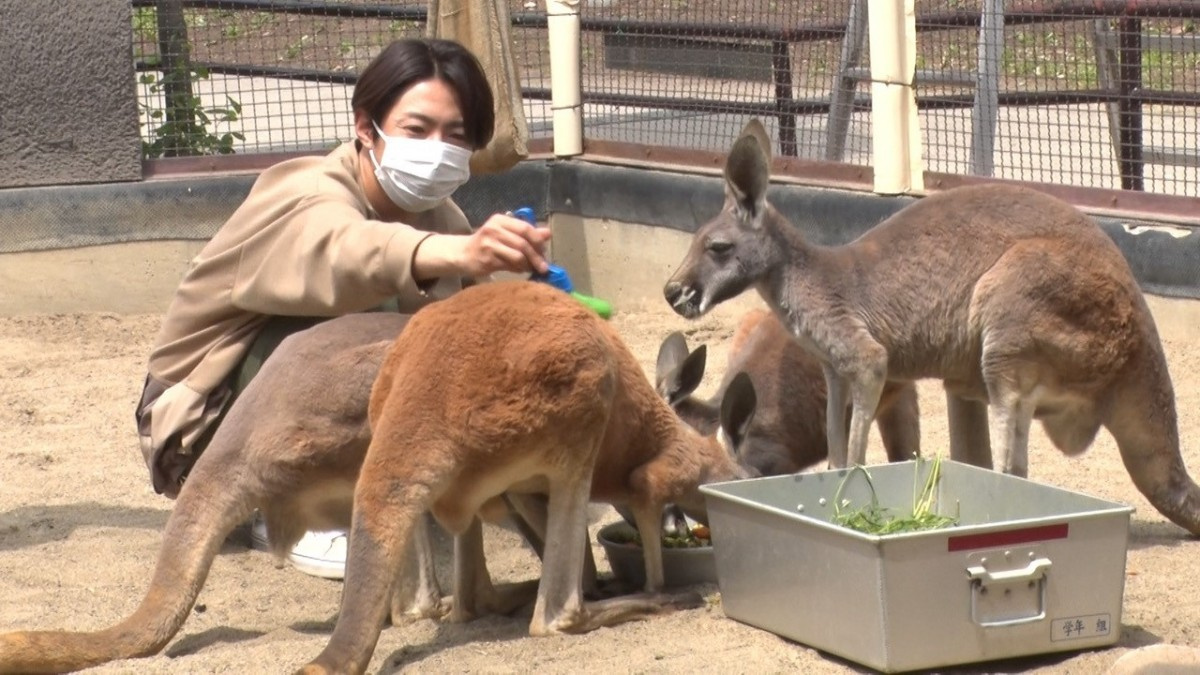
[662,119,780,318]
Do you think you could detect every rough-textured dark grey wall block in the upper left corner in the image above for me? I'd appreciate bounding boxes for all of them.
[0,0,142,187]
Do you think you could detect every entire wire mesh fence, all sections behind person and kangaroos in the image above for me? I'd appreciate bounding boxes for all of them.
[117,0,1200,195]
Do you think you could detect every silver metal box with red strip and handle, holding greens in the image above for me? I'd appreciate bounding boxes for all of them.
[702,460,1133,671]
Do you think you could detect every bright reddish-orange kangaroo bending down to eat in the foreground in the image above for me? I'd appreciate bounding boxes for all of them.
[301,281,748,674]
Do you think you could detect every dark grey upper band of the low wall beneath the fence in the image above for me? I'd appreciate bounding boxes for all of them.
[0,161,1200,298]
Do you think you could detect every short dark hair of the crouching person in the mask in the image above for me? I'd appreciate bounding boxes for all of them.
[350,37,496,149]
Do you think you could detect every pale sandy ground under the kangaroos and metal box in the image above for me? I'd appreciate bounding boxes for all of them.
[0,295,1200,674]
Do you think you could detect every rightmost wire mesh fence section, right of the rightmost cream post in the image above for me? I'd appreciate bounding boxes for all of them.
[917,0,1200,196]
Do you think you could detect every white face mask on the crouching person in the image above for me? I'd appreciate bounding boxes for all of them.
[367,123,470,213]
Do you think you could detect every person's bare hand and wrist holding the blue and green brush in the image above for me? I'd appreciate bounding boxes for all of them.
[413,214,550,280]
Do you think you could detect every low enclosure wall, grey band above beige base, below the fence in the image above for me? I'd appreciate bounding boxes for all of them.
[0,162,1200,315]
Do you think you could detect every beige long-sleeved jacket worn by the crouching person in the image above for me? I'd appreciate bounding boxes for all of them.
[137,142,470,491]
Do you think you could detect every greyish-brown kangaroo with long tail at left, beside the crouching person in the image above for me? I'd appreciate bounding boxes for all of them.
[0,312,544,673]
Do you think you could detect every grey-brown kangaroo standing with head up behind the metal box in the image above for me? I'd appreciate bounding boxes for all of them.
[664,120,1200,533]
